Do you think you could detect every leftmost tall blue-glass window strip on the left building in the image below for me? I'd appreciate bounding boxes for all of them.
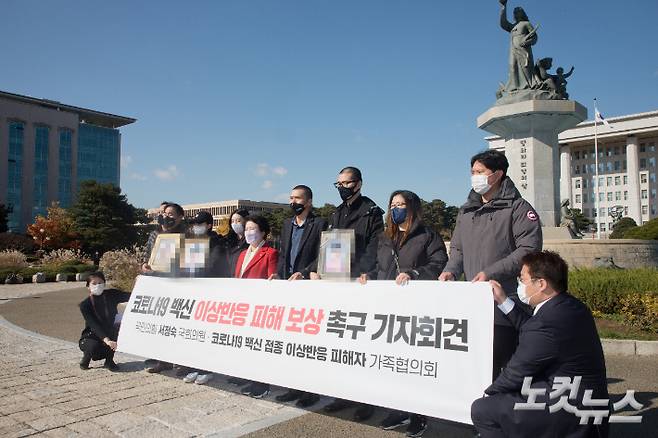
[7,122,25,229]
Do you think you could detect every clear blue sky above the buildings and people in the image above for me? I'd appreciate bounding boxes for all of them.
[0,0,658,207]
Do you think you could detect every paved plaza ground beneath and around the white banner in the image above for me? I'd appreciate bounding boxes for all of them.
[0,283,658,438]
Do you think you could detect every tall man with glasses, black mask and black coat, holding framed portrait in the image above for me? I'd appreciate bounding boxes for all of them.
[324,167,384,421]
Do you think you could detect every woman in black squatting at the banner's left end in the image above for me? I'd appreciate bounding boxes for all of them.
[78,272,130,371]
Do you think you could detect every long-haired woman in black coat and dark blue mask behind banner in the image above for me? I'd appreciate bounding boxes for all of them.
[359,190,448,437]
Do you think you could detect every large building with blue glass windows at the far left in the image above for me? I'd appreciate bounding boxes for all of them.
[0,91,135,233]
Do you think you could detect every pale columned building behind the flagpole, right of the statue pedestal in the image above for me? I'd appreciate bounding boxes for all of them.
[486,111,658,235]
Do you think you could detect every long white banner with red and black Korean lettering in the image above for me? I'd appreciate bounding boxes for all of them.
[118,277,494,424]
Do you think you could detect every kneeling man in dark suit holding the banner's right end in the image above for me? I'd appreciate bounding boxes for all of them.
[471,251,608,438]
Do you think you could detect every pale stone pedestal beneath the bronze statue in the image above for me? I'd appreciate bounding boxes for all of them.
[477,100,587,227]
